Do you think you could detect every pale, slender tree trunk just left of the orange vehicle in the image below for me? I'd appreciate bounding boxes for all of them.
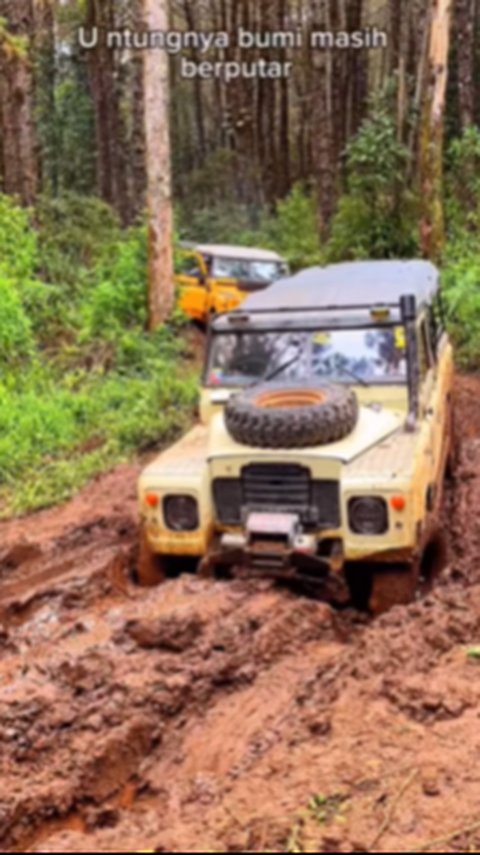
[143,0,175,331]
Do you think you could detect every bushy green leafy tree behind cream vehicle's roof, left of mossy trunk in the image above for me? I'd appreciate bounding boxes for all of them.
[327,102,418,261]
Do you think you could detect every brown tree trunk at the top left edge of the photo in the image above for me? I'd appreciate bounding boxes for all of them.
[0,0,38,205]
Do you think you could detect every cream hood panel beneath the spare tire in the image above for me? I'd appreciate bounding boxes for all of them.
[208,407,405,463]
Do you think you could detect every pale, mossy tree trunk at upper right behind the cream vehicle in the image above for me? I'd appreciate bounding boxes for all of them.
[419,0,452,261]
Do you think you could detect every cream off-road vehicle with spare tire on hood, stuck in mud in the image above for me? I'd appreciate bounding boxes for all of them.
[138,261,454,613]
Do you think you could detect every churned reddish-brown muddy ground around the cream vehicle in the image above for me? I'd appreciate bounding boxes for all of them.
[0,378,480,852]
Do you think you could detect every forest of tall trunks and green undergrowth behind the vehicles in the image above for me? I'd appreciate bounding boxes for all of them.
[0,0,480,512]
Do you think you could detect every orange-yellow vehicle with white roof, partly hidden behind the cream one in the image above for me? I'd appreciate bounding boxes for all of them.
[175,245,289,323]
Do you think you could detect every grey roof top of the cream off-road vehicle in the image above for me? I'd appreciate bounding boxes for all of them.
[241,261,439,312]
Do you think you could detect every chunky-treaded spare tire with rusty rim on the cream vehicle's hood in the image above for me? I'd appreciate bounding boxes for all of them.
[225,383,358,448]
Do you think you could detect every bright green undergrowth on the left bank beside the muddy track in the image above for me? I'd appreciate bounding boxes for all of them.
[0,194,198,515]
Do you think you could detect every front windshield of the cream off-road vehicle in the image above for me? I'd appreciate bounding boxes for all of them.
[207,327,407,386]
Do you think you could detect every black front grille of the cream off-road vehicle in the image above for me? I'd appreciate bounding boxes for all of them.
[213,463,341,529]
